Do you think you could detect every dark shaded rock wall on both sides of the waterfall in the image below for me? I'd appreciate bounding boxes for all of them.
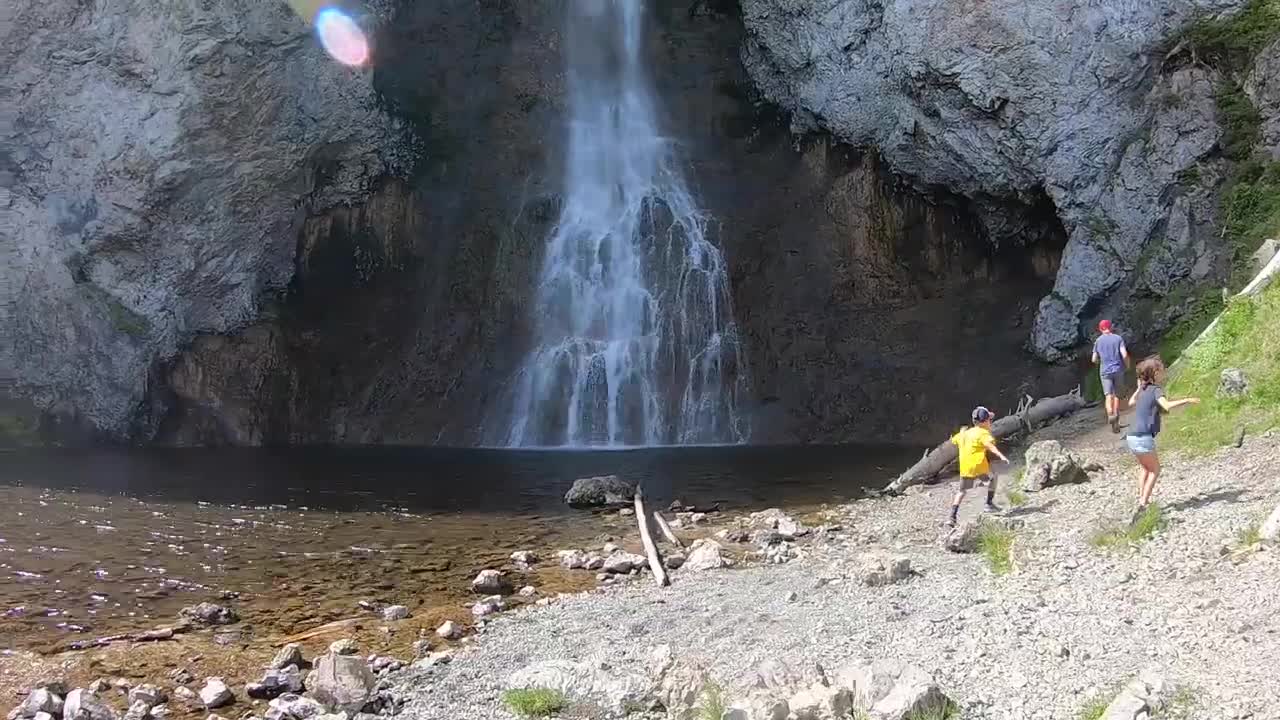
[152,0,1070,445]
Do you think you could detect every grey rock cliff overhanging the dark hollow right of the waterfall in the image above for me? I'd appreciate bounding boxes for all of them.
[742,0,1243,360]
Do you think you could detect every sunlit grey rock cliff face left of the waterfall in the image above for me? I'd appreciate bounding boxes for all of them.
[0,0,398,437]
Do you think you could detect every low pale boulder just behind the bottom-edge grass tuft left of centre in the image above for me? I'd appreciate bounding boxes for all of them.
[506,660,650,715]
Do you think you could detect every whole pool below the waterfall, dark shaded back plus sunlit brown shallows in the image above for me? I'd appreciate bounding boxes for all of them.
[0,447,918,651]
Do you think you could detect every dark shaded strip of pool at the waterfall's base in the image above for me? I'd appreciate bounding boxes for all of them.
[0,446,920,514]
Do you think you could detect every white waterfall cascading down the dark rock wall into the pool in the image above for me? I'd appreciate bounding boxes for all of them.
[494,0,748,446]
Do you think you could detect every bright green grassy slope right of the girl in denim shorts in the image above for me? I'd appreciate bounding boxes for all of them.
[1160,283,1280,455]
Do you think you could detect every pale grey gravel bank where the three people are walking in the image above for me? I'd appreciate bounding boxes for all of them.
[398,413,1280,720]
